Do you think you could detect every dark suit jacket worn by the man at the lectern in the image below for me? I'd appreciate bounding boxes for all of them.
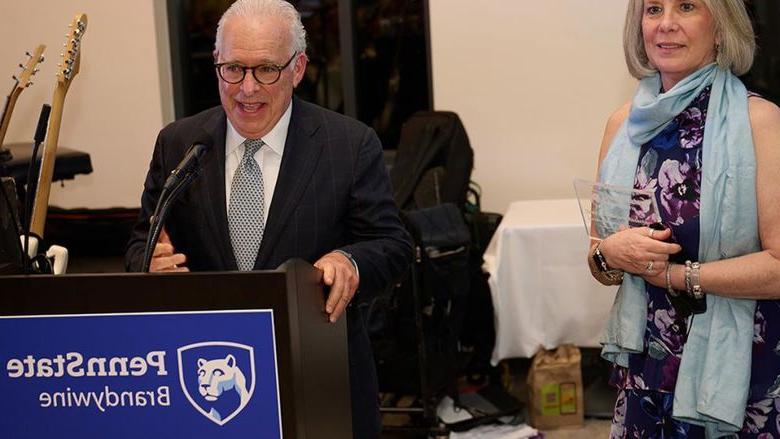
[125,99,412,437]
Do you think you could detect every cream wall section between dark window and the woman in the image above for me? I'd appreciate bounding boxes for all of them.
[430,0,636,212]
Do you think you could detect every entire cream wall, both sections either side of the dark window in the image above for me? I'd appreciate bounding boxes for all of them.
[0,0,635,212]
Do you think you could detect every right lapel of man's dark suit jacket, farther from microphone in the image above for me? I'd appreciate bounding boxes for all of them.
[256,98,322,269]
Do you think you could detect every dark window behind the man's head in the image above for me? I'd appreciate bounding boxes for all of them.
[167,0,433,149]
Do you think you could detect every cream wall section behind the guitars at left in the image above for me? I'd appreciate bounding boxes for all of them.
[0,0,172,208]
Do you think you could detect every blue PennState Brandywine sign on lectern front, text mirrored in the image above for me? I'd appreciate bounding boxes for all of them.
[0,310,282,439]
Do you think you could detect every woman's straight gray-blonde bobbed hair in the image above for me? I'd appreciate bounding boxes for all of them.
[623,0,756,79]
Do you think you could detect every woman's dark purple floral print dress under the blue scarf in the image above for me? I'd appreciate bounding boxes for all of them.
[610,87,780,439]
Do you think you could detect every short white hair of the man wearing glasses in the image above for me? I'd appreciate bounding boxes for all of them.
[214,0,306,54]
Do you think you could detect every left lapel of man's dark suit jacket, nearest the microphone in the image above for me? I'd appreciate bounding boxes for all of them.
[200,109,238,270]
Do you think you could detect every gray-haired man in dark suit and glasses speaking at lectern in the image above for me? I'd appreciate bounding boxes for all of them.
[126,0,412,438]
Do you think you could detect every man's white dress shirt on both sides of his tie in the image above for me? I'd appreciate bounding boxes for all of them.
[225,101,292,224]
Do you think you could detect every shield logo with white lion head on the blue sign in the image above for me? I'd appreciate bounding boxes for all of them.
[177,341,255,425]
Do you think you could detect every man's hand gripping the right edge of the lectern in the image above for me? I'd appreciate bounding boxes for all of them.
[314,252,359,323]
